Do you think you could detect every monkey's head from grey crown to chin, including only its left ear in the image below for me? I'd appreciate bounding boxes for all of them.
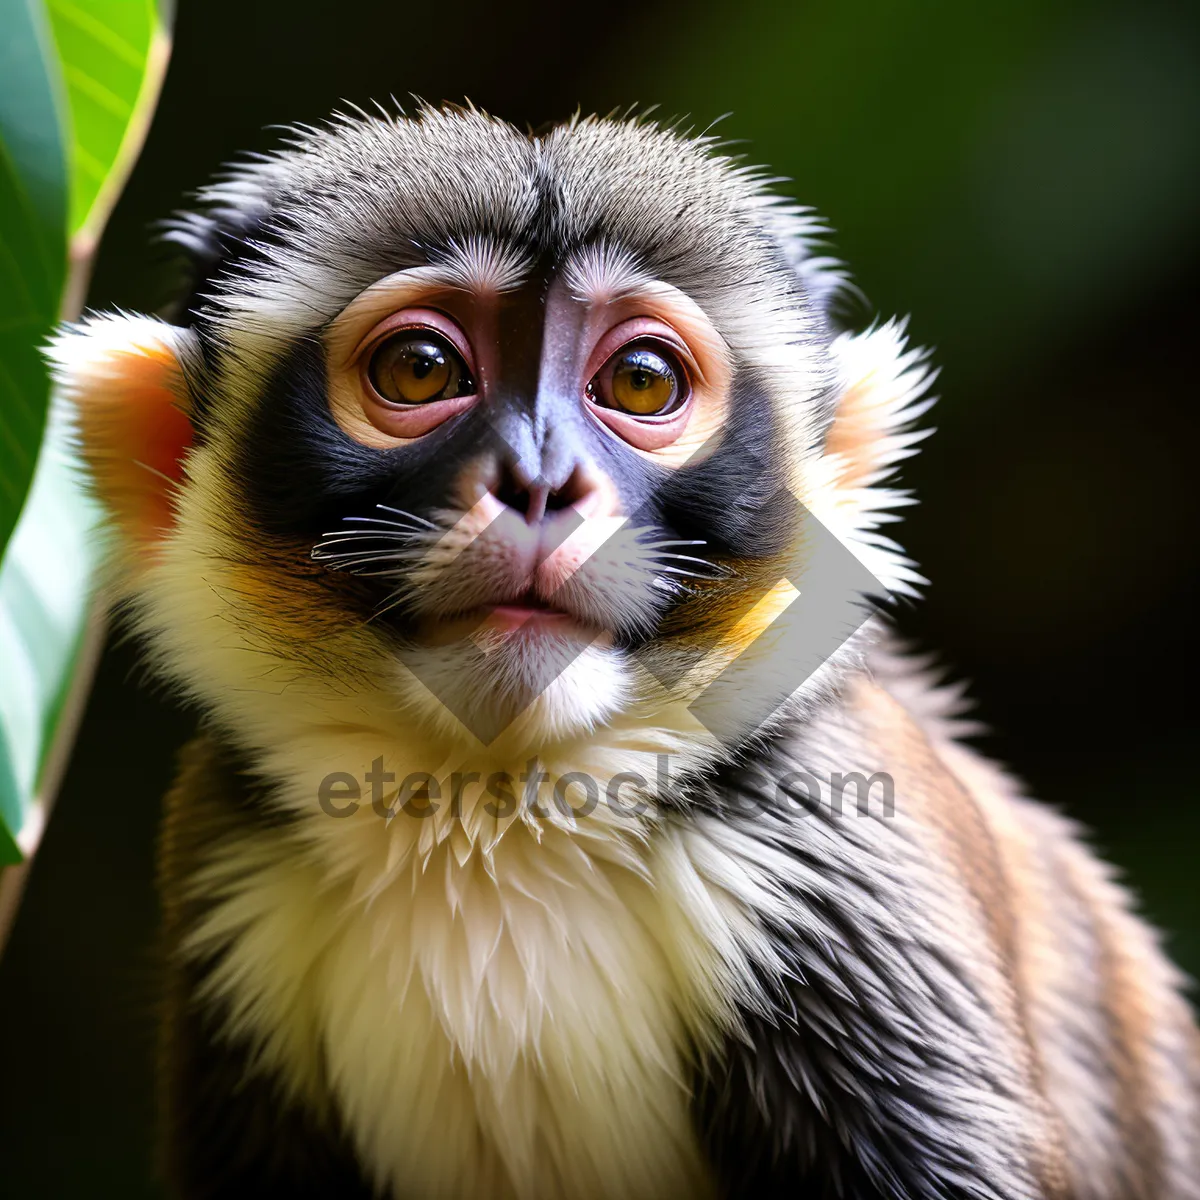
[51,110,921,768]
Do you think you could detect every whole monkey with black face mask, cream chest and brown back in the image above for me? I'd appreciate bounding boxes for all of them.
[48,104,1200,1200]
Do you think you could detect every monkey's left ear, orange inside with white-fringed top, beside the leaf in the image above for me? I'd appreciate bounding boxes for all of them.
[46,314,198,550]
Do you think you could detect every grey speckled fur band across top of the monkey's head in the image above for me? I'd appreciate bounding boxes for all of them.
[167,107,844,427]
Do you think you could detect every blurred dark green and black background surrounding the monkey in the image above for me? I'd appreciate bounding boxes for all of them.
[0,0,1200,1200]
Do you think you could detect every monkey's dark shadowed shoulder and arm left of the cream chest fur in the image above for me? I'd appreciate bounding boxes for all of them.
[158,733,377,1200]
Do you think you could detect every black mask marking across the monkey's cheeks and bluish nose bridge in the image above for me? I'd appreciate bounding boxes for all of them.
[234,314,793,647]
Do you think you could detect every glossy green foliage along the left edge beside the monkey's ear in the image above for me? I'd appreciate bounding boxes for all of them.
[0,0,168,864]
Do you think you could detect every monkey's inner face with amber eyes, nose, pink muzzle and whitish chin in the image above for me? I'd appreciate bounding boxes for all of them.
[282,240,806,740]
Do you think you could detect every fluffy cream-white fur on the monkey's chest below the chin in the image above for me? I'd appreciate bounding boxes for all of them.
[182,744,763,1200]
